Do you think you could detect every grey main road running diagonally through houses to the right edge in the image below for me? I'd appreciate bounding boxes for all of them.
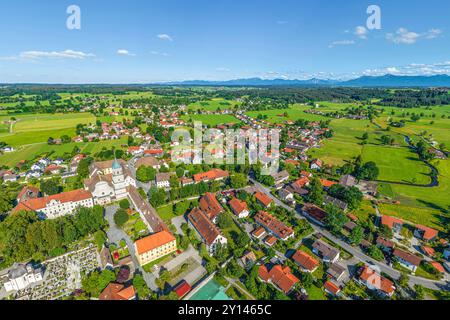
[250,178,450,290]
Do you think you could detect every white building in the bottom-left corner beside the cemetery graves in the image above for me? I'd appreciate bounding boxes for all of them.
[4,263,44,292]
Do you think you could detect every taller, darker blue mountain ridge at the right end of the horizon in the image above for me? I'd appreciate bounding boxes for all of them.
[340,74,450,87]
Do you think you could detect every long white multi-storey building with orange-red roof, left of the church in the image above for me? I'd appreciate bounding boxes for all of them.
[13,189,94,219]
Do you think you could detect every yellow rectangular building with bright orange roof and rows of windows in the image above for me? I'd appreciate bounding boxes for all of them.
[134,230,177,266]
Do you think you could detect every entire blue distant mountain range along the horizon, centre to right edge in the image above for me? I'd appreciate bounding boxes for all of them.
[159,74,450,87]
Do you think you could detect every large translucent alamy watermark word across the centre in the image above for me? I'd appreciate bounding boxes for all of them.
[171,121,280,175]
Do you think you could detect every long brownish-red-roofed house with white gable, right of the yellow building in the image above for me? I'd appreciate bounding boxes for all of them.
[188,208,228,255]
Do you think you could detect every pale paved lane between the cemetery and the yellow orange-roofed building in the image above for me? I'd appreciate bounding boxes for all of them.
[105,206,159,292]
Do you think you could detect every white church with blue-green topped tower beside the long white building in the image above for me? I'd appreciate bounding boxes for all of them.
[84,159,136,205]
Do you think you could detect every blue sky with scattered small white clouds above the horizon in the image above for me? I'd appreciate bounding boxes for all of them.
[0,0,450,83]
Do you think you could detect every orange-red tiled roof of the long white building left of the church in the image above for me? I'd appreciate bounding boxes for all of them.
[13,189,92,212]
